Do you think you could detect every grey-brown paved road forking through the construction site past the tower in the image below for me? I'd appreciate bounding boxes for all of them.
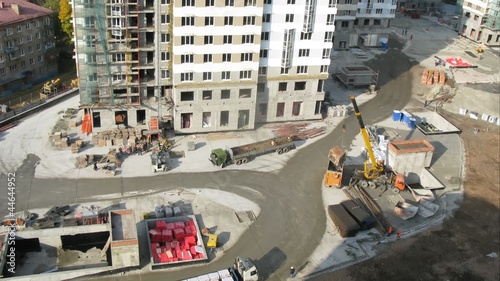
[0,33,411,280]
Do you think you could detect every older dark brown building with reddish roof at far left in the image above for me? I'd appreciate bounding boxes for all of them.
[0,0,57,94]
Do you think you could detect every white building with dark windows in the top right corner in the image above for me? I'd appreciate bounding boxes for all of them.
[457,0,500,46]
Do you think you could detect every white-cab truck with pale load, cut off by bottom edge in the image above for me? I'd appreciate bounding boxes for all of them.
[183,257,259,281]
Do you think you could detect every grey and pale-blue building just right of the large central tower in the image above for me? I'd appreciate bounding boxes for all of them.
[329,0,397,49]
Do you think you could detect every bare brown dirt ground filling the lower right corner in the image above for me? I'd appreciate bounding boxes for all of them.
[312,107,500,281]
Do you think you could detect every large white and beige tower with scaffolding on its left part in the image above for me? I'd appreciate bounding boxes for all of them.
[72,0,336,133]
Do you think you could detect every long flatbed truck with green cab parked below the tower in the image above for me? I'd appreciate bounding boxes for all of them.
[209,136,295,168]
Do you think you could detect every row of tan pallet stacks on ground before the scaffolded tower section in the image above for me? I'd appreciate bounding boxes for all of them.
[91,128,142,147]
